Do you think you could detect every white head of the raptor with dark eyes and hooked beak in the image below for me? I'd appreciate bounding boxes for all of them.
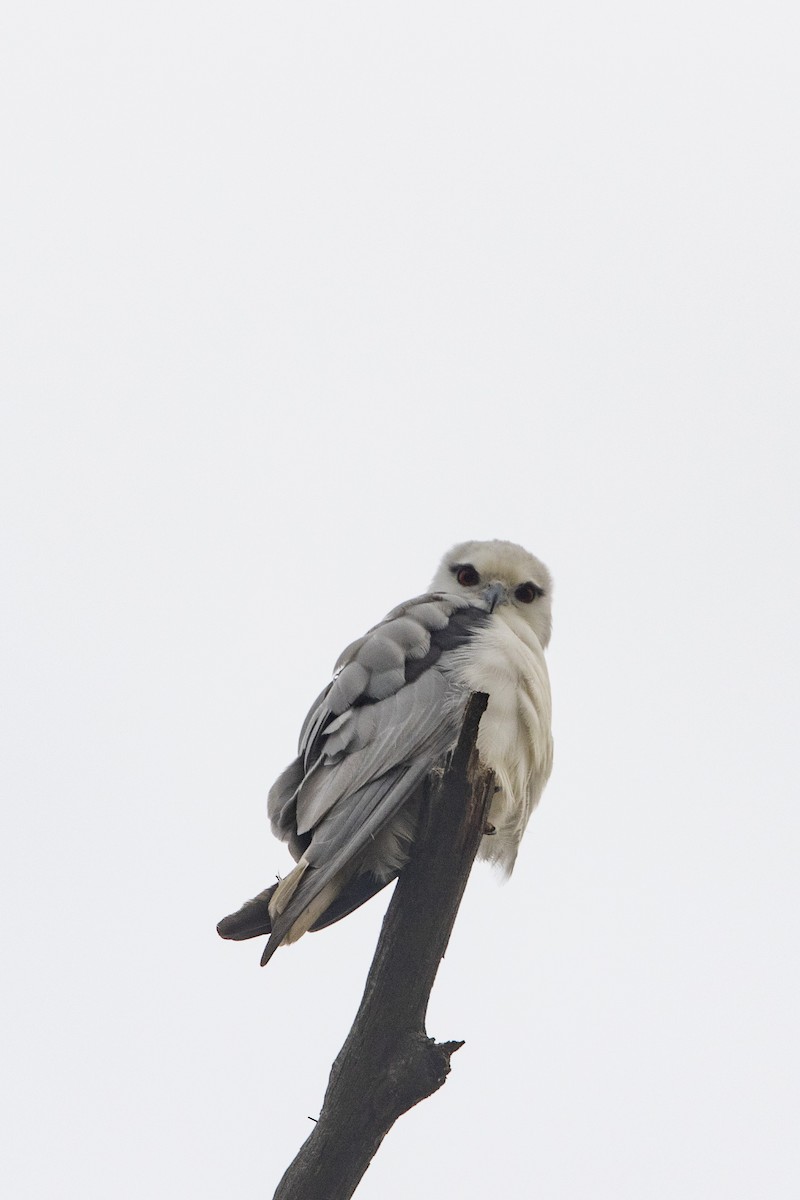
[431,541,553,647]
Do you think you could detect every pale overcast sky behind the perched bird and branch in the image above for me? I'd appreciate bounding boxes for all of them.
[0,0,800,1200]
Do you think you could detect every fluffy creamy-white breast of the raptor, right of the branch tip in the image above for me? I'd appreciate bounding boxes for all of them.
[456,605,553,874]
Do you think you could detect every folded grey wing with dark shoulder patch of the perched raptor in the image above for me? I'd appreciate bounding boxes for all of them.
[260,593,489,956]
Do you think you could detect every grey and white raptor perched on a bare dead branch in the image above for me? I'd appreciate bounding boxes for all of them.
[217,541,553,966]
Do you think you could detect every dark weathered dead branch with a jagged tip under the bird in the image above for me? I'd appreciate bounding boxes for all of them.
[273,694,494,1200]
